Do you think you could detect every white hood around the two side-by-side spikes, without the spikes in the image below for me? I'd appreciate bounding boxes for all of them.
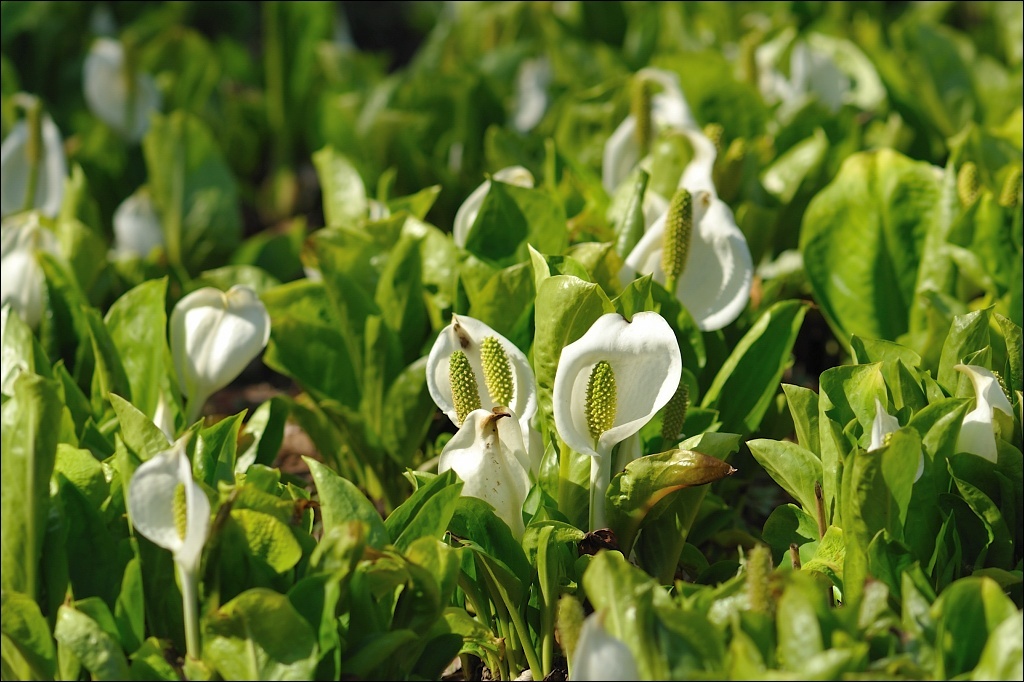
[427,314,537,433]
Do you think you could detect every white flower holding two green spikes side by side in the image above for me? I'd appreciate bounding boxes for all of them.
[427,315,537,433]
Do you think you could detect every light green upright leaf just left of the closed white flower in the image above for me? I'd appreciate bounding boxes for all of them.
[103,278,170,417]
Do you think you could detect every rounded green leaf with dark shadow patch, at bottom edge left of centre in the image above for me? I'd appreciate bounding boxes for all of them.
[203,588,317,680]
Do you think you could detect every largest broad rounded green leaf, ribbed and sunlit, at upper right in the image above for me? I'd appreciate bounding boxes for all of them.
[800,150,940,341]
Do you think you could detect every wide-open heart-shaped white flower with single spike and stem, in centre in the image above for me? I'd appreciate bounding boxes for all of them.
[553,312,683,530]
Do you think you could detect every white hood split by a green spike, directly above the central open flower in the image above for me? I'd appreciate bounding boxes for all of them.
[620,190,754,332]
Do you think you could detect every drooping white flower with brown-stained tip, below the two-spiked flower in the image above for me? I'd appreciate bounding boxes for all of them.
[437,408,530,539]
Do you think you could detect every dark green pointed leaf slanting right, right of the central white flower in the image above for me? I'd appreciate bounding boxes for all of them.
[700,300,808,433]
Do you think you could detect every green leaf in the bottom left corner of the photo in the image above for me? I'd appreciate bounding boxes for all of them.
[0,589,56,680]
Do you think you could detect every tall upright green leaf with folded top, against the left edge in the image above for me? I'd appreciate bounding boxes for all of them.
[0,373,61,599]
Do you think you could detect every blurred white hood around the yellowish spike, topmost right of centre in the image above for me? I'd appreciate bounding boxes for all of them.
[601,69,715,195]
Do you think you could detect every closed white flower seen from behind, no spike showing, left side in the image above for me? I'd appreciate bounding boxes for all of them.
[170,285,270,424]
